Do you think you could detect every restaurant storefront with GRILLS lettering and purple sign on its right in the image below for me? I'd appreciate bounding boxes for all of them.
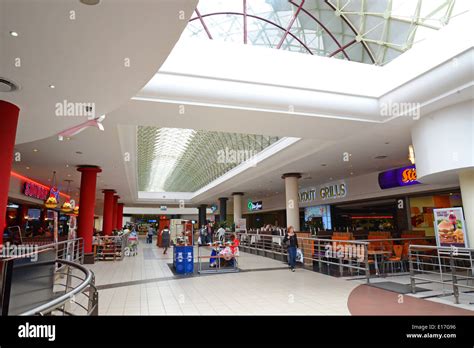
[299,166,462,236]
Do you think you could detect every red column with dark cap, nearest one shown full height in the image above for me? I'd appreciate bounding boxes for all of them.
[77,166,102,263]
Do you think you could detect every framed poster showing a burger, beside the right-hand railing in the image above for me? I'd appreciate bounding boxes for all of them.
[433,208,469,248]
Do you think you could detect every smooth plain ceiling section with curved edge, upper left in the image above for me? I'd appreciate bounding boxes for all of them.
[0,0,197,144]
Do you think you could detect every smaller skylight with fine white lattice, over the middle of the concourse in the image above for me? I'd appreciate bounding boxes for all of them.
[137,126,279,192]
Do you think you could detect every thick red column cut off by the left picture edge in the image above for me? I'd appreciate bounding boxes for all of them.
[0,100,20,244]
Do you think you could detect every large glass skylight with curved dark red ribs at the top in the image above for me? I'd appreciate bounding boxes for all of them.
[186,0,466,65]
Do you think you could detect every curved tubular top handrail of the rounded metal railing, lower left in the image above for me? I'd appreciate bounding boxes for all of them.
[19,260,97,316]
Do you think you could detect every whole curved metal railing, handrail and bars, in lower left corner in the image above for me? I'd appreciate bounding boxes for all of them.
[19,260,98,316]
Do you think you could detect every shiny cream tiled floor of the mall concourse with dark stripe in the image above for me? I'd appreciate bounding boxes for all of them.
[84,240,474,315]
